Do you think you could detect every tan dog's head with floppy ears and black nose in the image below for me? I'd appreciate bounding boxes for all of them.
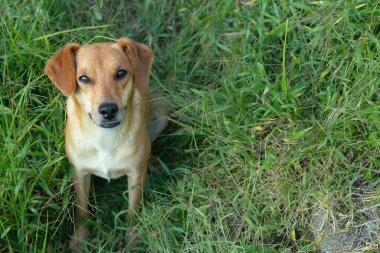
[45,38,153,128]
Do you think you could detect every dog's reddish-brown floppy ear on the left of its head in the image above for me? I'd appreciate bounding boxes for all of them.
[45,44,80,96]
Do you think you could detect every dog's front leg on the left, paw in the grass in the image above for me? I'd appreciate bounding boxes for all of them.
[70,171,91,252]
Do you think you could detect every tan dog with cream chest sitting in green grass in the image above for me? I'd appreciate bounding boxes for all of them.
[45,38,168,251]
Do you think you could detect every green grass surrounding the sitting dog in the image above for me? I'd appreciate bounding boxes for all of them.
[0,0,380,252]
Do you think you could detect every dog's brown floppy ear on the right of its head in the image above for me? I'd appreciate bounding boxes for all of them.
[117,38,153,91]
